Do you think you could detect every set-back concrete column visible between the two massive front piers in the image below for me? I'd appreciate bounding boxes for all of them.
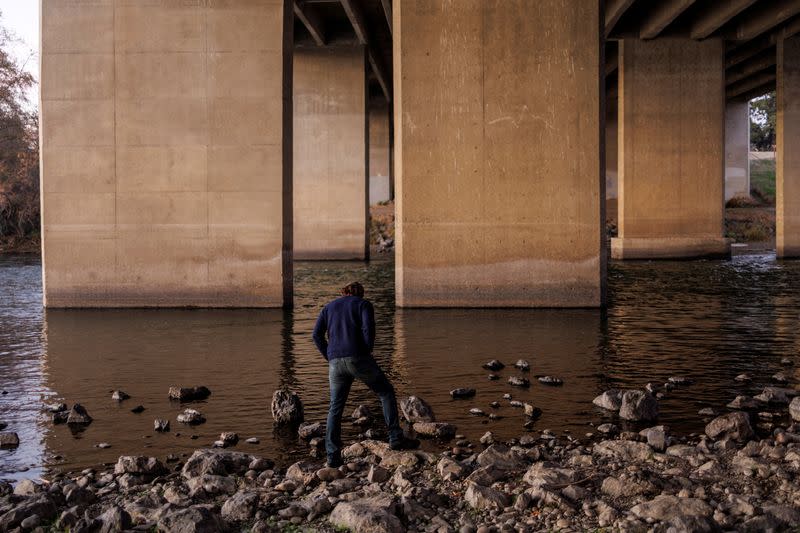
[294,46,369,259]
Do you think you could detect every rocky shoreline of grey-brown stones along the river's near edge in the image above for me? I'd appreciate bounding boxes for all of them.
[0,393,800,533]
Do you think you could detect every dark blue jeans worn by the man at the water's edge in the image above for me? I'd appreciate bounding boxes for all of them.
[325,357,403,459]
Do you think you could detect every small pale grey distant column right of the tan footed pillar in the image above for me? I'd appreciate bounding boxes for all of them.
[725,101,750,202]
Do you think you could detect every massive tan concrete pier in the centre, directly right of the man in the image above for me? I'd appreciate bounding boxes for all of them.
[393,0,605,307]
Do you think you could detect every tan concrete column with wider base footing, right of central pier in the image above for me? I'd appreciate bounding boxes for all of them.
[611,39,728,259]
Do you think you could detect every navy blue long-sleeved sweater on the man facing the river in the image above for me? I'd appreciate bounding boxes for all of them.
[313,296,375,361]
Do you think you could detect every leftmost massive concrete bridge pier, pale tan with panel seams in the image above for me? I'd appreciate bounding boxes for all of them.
[41,0,292,307]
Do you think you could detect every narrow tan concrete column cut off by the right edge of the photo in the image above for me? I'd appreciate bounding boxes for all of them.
[775,35,800,258]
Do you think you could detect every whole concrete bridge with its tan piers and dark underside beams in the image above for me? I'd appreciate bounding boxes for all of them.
[41,0,800,307]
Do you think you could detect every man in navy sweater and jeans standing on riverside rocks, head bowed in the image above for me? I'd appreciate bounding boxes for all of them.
[313,282,419,468]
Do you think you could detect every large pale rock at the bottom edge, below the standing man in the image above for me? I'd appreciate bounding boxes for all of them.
[328,494,405,533]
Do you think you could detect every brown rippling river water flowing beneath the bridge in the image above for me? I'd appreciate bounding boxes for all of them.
[0,251,800,479]
